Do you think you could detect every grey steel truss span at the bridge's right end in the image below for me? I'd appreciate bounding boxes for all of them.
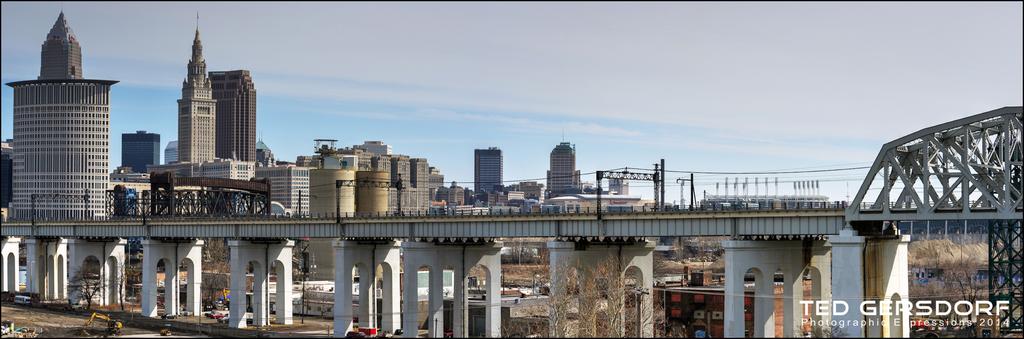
[846,107,1022,225]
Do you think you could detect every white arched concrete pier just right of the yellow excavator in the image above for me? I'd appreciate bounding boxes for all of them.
[142,239,206,317]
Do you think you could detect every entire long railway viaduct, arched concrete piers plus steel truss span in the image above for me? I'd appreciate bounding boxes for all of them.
[2,107,1022,337]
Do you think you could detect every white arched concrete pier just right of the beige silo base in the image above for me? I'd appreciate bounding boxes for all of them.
[332,240,401,338]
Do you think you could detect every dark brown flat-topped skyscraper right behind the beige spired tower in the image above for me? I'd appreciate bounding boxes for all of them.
[210,70,256,161]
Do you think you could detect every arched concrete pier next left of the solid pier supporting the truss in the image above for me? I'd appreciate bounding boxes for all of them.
[722,240,833,338]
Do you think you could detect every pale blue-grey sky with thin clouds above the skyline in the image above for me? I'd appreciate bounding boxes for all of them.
[0,2,1024,201]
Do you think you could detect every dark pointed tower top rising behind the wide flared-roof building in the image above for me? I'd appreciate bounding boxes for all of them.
[39,10,82,80]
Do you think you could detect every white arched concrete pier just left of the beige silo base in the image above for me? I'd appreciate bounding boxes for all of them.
[227,240,295,329]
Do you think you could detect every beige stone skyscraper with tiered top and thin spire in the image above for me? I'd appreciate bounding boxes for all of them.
[178,28,217,163]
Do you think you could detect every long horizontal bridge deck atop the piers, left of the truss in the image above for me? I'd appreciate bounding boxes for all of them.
[0,209,845,239]
